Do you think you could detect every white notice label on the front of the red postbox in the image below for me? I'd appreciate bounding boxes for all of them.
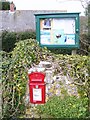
[33,88,42,101]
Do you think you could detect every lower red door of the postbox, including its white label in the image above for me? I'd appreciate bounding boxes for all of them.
[30,83,45,104]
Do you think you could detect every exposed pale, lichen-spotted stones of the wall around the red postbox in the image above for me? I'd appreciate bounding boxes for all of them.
[24,61,79,118]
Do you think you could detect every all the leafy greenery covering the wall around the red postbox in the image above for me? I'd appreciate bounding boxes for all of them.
[0,39,90,117]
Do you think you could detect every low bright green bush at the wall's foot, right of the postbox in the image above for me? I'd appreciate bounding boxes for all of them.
[37,96,88,118]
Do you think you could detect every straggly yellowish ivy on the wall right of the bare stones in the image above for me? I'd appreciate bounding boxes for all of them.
[54,55,90,117]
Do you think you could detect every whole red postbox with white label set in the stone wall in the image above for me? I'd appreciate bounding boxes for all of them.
[28,72,45,104]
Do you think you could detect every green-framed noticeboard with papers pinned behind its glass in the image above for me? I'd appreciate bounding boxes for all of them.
[35,13,79,49]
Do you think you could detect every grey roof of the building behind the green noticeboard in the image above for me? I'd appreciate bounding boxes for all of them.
[0,10,66,32]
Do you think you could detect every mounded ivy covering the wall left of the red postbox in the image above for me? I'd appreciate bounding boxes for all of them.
[1,39,49,117]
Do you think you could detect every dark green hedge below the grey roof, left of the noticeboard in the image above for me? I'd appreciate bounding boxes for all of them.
[1,31,36,52]
